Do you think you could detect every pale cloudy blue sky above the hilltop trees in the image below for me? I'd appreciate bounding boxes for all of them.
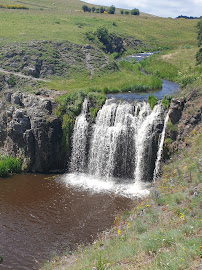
[85,0,202,18]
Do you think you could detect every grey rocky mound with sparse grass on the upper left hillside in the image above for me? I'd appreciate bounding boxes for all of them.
[0,41,112,79]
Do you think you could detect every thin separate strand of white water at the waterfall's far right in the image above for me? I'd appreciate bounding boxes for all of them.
[153,110,170,181]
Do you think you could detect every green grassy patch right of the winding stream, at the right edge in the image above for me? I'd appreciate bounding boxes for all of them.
[142,45,202,87]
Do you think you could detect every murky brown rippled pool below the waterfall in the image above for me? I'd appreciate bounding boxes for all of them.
[0,174,134,270]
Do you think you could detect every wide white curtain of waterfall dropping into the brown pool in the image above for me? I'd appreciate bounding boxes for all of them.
[70,100,165,182]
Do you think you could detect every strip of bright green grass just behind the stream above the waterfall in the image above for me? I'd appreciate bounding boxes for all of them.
[45,62,162,93]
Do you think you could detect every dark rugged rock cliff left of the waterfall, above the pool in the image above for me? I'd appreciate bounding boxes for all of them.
[0,92,67,172]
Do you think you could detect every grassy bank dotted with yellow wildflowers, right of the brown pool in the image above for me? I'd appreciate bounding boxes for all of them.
[42,123,202,270]
